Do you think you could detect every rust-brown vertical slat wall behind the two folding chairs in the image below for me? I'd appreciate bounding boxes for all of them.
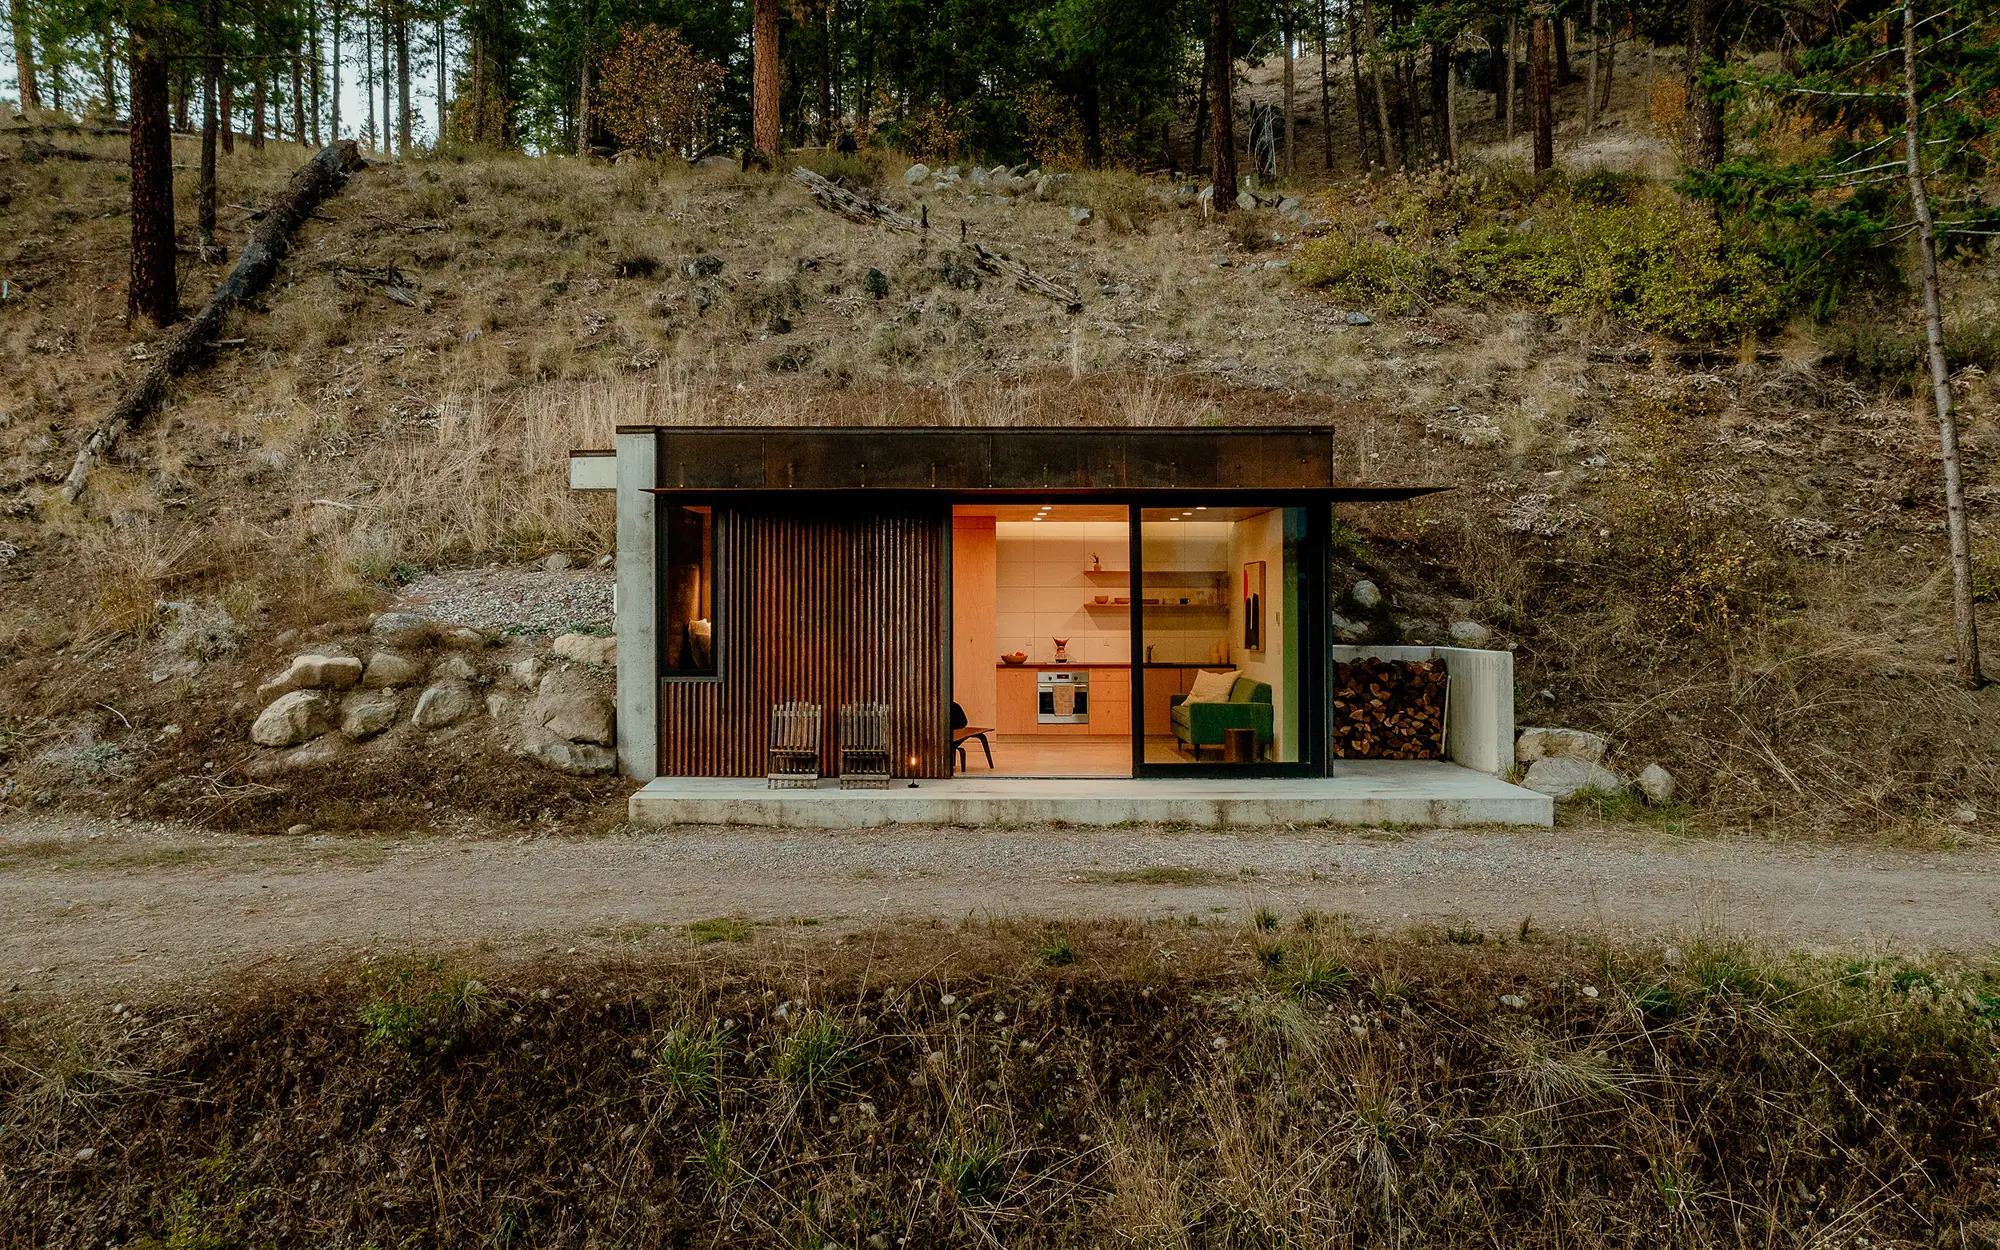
[660,506,952,778]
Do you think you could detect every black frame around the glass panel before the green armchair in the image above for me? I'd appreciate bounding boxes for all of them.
[1126,496,1334,778]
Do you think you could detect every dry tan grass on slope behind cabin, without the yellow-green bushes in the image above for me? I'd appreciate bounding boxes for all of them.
[0,100,2000,838]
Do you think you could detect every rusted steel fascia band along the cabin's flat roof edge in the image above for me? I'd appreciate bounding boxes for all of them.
[620,426,1442,492]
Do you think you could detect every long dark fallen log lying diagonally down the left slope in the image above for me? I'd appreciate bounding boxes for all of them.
[62,140,366,504]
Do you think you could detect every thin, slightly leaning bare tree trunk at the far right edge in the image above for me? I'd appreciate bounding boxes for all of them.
[1902,0,1986,688]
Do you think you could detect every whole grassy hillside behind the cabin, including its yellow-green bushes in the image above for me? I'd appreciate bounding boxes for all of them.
[0,56,2000,838]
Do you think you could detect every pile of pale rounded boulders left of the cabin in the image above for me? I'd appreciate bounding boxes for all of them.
[250,612,618,776]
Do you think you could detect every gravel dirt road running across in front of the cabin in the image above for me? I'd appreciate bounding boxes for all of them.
[0,818,2000,992]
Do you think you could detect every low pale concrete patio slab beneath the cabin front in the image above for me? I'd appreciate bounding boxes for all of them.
[628,760,1556,828]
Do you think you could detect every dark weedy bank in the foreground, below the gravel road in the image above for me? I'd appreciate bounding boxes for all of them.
[0,918,2000,1250]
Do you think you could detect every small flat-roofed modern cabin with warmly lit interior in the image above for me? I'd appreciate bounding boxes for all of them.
[570,426,1512,808]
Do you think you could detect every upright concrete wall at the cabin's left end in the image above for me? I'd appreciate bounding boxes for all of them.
[614,430,660,782]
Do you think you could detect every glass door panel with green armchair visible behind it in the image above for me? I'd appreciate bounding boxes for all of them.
[1130,504,1324,776]
